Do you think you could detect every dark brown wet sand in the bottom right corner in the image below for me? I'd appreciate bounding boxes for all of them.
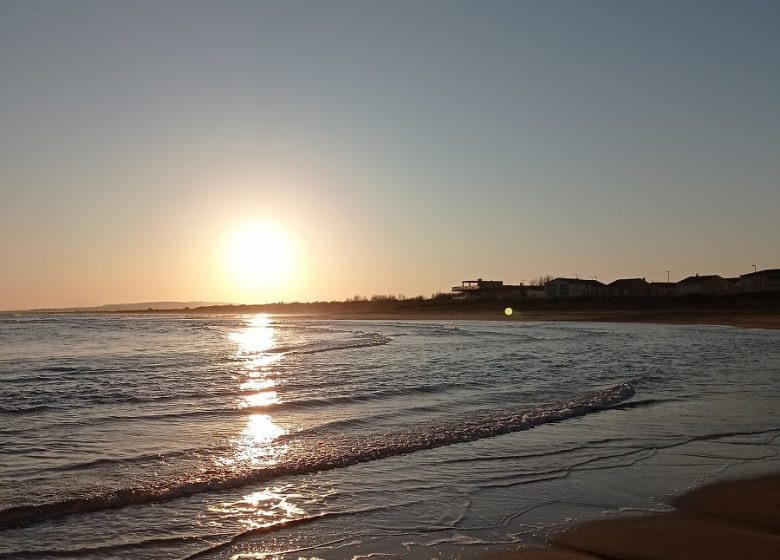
[489,475,780,560]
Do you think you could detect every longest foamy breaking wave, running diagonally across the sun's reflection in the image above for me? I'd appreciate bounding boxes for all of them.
[0,383,634,529]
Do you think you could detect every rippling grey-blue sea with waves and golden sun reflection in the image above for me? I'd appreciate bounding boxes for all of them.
[0,315,780,559]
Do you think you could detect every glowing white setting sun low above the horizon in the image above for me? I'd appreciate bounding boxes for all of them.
[227,221,294,297]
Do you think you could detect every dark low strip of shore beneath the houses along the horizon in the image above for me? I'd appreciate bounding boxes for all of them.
[10,292,780,329]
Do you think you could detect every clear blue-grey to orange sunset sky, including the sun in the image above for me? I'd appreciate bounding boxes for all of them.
[0,0,780,309]
